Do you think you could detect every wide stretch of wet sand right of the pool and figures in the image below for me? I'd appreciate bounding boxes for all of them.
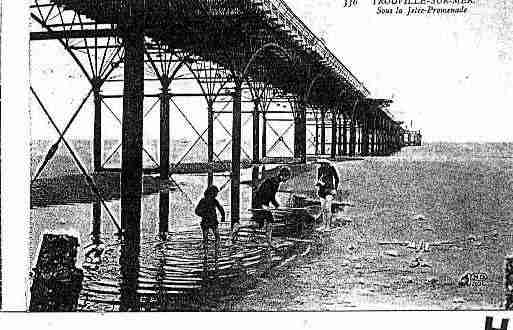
[228,144,513,311]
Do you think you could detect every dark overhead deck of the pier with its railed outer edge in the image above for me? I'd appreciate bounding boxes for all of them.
[51,0,369,104]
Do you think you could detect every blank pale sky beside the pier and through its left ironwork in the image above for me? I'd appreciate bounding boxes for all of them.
[31,0,513,142]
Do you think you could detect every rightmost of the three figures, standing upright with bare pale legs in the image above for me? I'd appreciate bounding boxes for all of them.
[316,159,339,230]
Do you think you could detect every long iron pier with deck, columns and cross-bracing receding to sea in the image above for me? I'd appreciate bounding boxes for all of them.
[31,0,421,300]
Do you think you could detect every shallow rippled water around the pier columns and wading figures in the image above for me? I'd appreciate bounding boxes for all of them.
[30,170,310,311]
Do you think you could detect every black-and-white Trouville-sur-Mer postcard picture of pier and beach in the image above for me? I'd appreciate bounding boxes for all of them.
[14,0,513,314]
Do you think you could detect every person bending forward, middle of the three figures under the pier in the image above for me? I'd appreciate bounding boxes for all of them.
[253,167,290,246]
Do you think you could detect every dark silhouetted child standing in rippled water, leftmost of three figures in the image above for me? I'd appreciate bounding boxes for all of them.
[195,186,225,252]
